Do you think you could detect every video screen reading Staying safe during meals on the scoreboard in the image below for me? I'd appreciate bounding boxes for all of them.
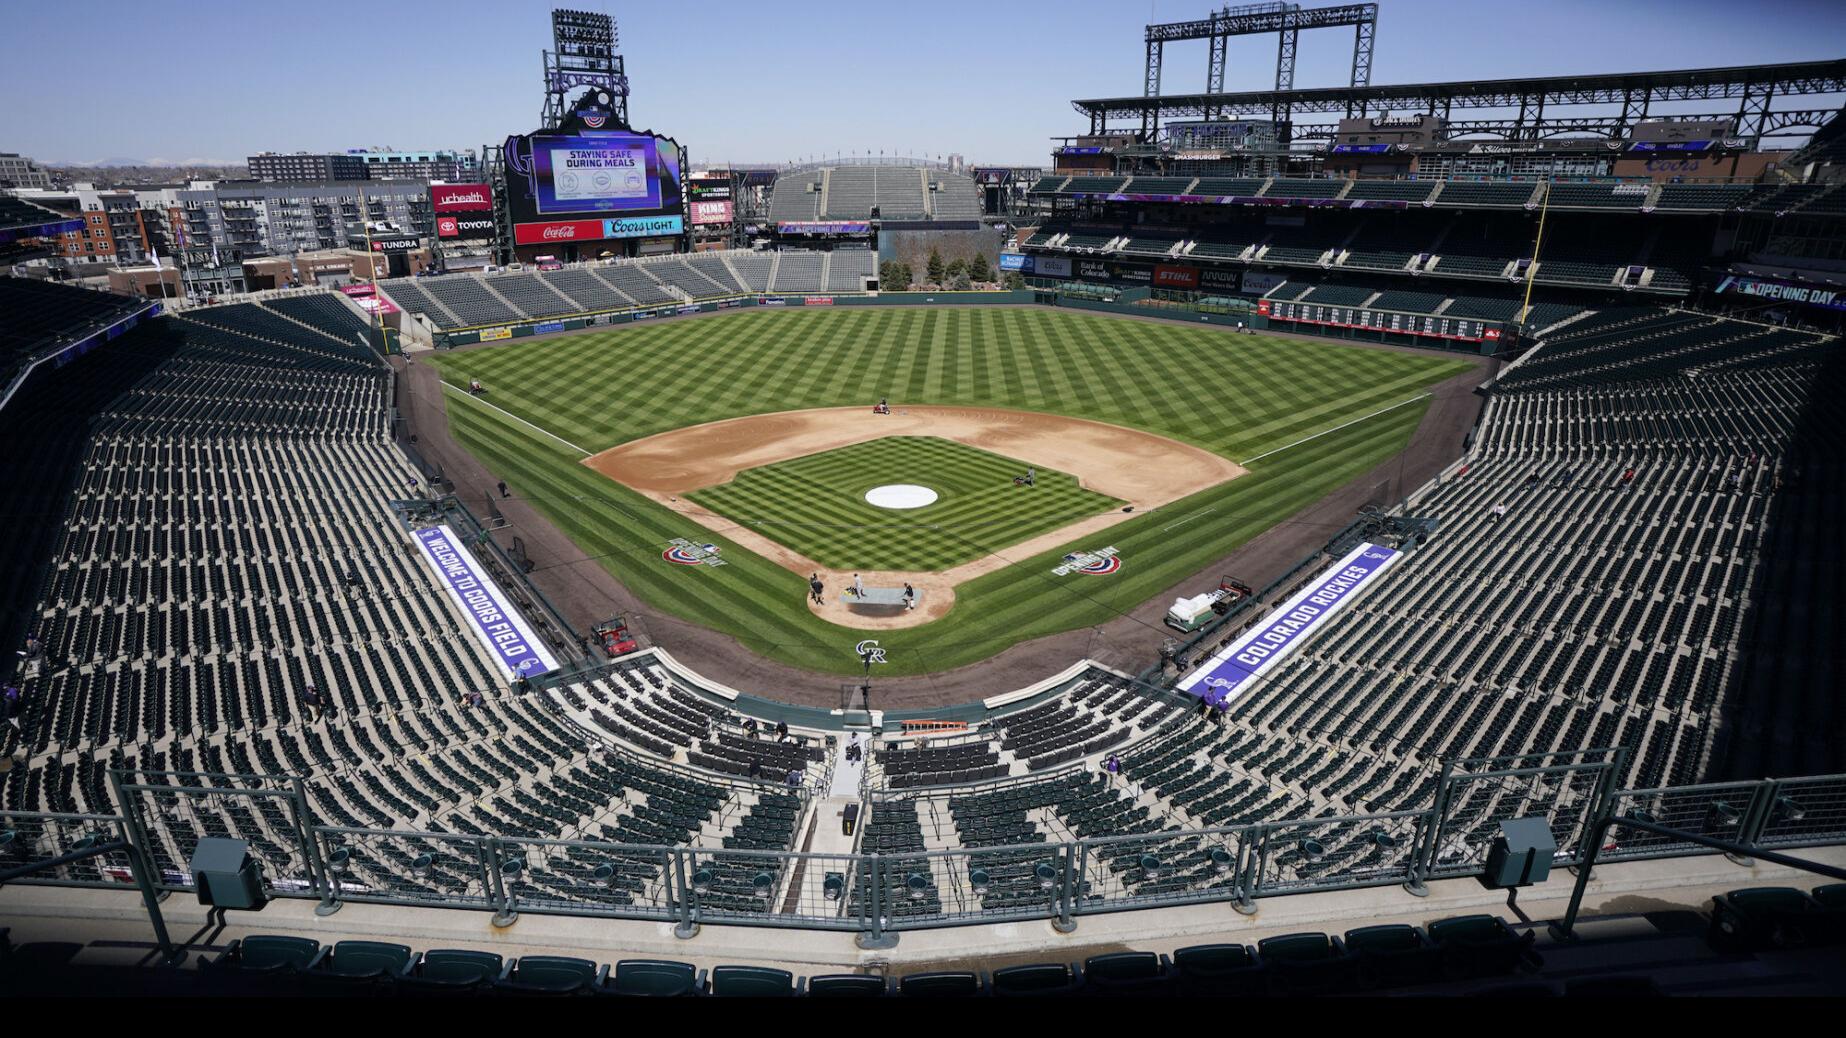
[532,135,665,216]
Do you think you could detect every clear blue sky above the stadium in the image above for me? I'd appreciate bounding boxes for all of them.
[0,0,1846,166]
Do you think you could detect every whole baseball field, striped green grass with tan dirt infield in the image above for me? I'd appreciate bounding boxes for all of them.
[432,307,1468,674]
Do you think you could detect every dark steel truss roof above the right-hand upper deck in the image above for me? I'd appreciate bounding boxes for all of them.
[1071,59,1846,144]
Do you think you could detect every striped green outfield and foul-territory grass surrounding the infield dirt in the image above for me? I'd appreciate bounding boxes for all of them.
[434,307,1466,675]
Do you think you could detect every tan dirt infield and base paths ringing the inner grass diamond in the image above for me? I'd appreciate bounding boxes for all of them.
[583,404,1246,630]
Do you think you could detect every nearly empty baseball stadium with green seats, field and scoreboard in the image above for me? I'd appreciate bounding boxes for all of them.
[0,2,1846,1005]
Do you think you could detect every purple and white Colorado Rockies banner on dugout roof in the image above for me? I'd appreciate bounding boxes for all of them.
[1180,543,1403,707]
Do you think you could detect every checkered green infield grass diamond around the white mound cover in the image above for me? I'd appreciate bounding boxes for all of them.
[689,436,1122,571]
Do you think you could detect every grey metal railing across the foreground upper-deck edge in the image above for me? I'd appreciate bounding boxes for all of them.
[0,752,1846,944]
